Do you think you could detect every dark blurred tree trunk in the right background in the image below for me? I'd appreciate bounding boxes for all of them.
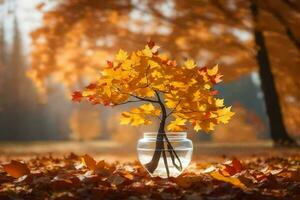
[250,0,296,146]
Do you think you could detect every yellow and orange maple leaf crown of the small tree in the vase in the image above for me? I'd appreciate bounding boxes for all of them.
[73,41,233,132]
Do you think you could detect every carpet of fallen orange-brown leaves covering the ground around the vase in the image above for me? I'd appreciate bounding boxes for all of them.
[0,154,300,200]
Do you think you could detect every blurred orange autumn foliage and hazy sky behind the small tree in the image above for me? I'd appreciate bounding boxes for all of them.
[0,0,300,154]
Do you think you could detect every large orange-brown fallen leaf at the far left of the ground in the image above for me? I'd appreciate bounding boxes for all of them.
[2,160,30,178]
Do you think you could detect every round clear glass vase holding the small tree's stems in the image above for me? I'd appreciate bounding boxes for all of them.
[137,132,193,178]
